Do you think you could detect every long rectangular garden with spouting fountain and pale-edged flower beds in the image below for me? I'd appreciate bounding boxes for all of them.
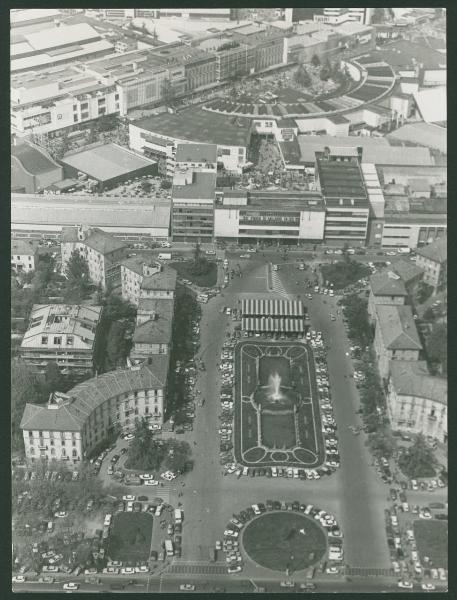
[235,341,325,468]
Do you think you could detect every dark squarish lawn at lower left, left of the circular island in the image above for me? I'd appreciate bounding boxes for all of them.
[108,513,152,564]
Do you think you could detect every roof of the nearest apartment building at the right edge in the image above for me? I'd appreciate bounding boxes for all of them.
[390,360,447,404]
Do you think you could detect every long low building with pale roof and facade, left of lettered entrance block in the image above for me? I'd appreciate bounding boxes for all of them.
[11,193,171,241]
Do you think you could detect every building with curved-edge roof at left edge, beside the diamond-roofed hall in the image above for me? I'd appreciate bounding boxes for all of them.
[11,140,63,194]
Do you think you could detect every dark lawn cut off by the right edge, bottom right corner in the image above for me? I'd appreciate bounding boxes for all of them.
[413,520,448,569]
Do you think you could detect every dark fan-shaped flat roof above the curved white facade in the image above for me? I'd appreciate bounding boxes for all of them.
[132,107,251,147]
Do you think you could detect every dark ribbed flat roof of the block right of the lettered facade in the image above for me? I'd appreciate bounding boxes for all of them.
[316,159,367,199]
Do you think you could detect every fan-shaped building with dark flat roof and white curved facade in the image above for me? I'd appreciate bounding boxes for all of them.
[129,107,251,176]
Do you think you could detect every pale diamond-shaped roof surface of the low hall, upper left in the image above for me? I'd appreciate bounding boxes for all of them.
[61,144,156,181]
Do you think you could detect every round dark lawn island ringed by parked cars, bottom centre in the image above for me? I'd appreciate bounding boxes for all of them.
[243,511,327,571]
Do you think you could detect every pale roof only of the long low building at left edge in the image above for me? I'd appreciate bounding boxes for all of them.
[11,194,171,229]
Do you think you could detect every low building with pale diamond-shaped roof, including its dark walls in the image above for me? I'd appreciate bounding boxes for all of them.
[61,143,157,192]
